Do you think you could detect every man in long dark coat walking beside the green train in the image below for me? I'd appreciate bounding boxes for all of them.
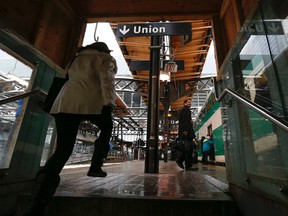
[176,99,197,170]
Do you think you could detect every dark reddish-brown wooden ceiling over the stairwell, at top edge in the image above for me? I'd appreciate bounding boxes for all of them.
[66,0,223,23]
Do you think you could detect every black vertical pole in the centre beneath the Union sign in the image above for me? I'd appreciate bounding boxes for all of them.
[145,36,160,173]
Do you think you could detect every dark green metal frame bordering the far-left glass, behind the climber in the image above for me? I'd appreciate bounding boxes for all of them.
[0,30,63,179]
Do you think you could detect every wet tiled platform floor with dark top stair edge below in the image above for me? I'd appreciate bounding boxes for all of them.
[15,160,240,216]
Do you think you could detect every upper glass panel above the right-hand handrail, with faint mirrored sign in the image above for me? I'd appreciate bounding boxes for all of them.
[239,20,288,120]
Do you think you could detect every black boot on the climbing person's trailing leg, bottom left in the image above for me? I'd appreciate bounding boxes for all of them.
[23,171,60,216]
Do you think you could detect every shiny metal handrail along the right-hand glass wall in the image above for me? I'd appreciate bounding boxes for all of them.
[218,88,288,133]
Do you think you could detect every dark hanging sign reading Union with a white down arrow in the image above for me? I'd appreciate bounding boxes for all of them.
[116,22,192,37]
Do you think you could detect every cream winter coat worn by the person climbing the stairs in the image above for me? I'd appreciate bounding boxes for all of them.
[50,49,117,114]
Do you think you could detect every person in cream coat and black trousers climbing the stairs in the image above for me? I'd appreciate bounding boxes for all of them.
[24,42,117,216]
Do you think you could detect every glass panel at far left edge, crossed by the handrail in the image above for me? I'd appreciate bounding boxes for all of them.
[0,50,32,169]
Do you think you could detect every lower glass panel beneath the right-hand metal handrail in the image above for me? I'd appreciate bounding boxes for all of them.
[243,105,288,180]
